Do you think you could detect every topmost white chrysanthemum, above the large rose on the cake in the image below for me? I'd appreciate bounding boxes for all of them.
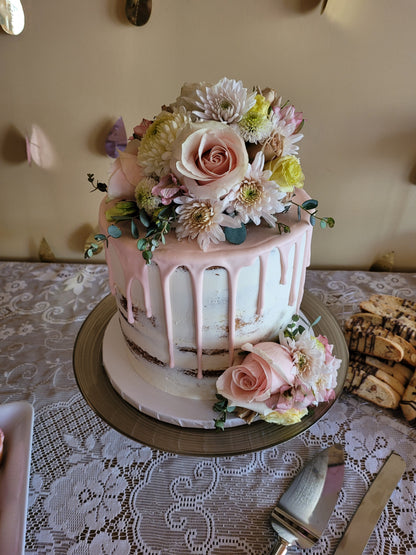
[193,77,256,123]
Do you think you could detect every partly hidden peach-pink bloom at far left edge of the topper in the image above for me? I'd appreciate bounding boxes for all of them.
[108,140,144,200]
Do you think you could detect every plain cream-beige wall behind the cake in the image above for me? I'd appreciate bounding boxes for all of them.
[0,0,416,270]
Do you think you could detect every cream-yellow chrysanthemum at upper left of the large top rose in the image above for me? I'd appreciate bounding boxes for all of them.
[137,107,191,177]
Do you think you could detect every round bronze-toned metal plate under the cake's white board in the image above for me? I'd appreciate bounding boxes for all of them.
[73,291,348,456]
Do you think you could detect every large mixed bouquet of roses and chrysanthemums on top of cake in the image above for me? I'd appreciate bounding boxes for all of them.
[85,77,334,263]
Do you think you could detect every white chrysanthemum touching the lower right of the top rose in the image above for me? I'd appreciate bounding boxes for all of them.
[227,152,285,227]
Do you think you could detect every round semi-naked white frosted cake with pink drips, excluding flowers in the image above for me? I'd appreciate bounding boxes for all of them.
[100,190,312,398]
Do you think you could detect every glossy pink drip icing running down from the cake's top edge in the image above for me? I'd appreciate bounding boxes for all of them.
[100,187,312,378]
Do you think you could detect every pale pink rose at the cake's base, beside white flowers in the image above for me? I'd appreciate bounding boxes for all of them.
[217,342,295,411]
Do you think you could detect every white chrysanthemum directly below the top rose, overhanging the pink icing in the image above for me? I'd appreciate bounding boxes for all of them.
[175,197,240,251]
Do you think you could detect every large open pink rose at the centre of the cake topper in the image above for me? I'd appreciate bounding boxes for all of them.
[171,122,248,200]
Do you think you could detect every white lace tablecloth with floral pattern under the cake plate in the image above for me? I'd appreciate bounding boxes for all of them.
[0,262,416,555]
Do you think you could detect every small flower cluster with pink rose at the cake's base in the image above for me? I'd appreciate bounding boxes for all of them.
[214,315,341,429]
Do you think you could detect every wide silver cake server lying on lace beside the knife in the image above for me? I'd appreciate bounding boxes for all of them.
[270,444,344,555]
